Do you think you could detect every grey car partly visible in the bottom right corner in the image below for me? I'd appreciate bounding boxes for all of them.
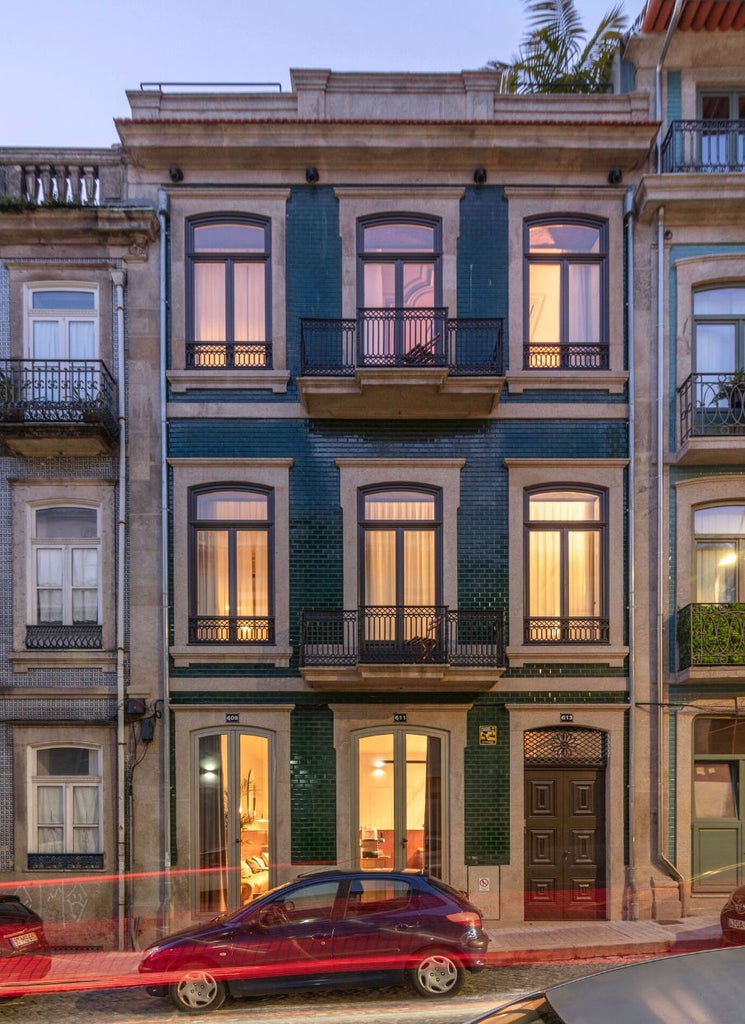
[462,947,745,1024]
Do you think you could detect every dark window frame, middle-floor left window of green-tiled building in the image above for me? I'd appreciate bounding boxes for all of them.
[188,482,275,646]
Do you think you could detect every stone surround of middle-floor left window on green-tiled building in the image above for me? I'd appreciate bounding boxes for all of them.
[168,458,293,668]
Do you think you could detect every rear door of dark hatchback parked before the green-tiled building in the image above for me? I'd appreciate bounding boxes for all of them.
[334,873,421,971]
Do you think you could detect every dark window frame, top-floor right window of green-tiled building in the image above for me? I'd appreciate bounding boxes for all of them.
[522,211,611,373]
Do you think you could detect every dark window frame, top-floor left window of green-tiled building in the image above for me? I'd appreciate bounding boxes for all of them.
[184,212,274,373]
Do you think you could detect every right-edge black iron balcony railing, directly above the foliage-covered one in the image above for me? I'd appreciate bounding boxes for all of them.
[677,371,745,443]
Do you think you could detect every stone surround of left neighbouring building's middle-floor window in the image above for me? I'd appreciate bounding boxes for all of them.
[8,478,117,673]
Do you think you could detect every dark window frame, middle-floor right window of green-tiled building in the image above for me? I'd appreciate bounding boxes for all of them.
[523,483,609,646]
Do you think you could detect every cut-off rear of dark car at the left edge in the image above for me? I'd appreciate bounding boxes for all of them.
[0,895,51,999]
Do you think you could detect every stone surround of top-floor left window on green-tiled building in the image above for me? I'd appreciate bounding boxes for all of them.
[166,192,291,393]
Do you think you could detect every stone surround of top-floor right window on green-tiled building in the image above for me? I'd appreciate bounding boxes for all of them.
[505,186,628,394]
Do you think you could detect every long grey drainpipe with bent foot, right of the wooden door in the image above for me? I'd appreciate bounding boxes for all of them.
[656,206,687,918]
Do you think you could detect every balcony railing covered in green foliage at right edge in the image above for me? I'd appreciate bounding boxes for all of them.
[677,602,745,669]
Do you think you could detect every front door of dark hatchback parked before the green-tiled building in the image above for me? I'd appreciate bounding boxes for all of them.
[224,879,340,992]
